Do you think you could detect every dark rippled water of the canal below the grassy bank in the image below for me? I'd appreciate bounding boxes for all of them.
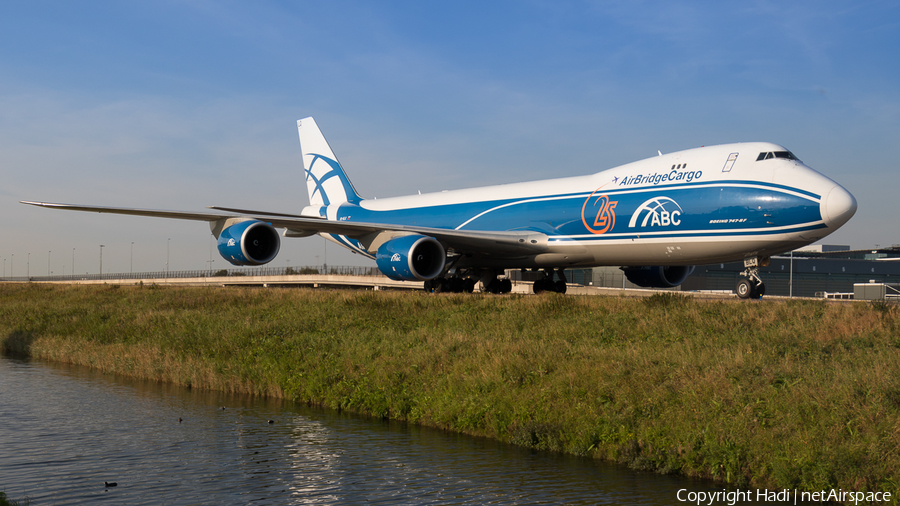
[0,358,800,505]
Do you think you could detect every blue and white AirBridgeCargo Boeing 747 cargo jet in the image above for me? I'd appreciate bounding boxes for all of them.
[21,117,857,299]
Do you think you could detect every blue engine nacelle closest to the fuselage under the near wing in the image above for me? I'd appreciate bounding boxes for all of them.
[375,234,447,281]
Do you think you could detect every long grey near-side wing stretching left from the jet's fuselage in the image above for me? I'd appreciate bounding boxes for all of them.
[20,200,548,256]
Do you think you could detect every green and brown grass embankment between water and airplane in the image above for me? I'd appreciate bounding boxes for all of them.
[0,285,900,493]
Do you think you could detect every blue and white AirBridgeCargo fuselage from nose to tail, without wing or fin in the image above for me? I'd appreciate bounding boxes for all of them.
[312,142,856,268]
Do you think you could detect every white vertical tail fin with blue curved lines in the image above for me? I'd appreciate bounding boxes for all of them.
[297,117,362,206]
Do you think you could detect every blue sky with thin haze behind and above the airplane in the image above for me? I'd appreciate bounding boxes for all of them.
[0,0,900,275]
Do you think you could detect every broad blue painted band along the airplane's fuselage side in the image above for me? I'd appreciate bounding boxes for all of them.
[338,181,822,237]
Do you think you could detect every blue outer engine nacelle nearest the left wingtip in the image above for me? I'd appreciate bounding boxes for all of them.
[217,220,281,265]
